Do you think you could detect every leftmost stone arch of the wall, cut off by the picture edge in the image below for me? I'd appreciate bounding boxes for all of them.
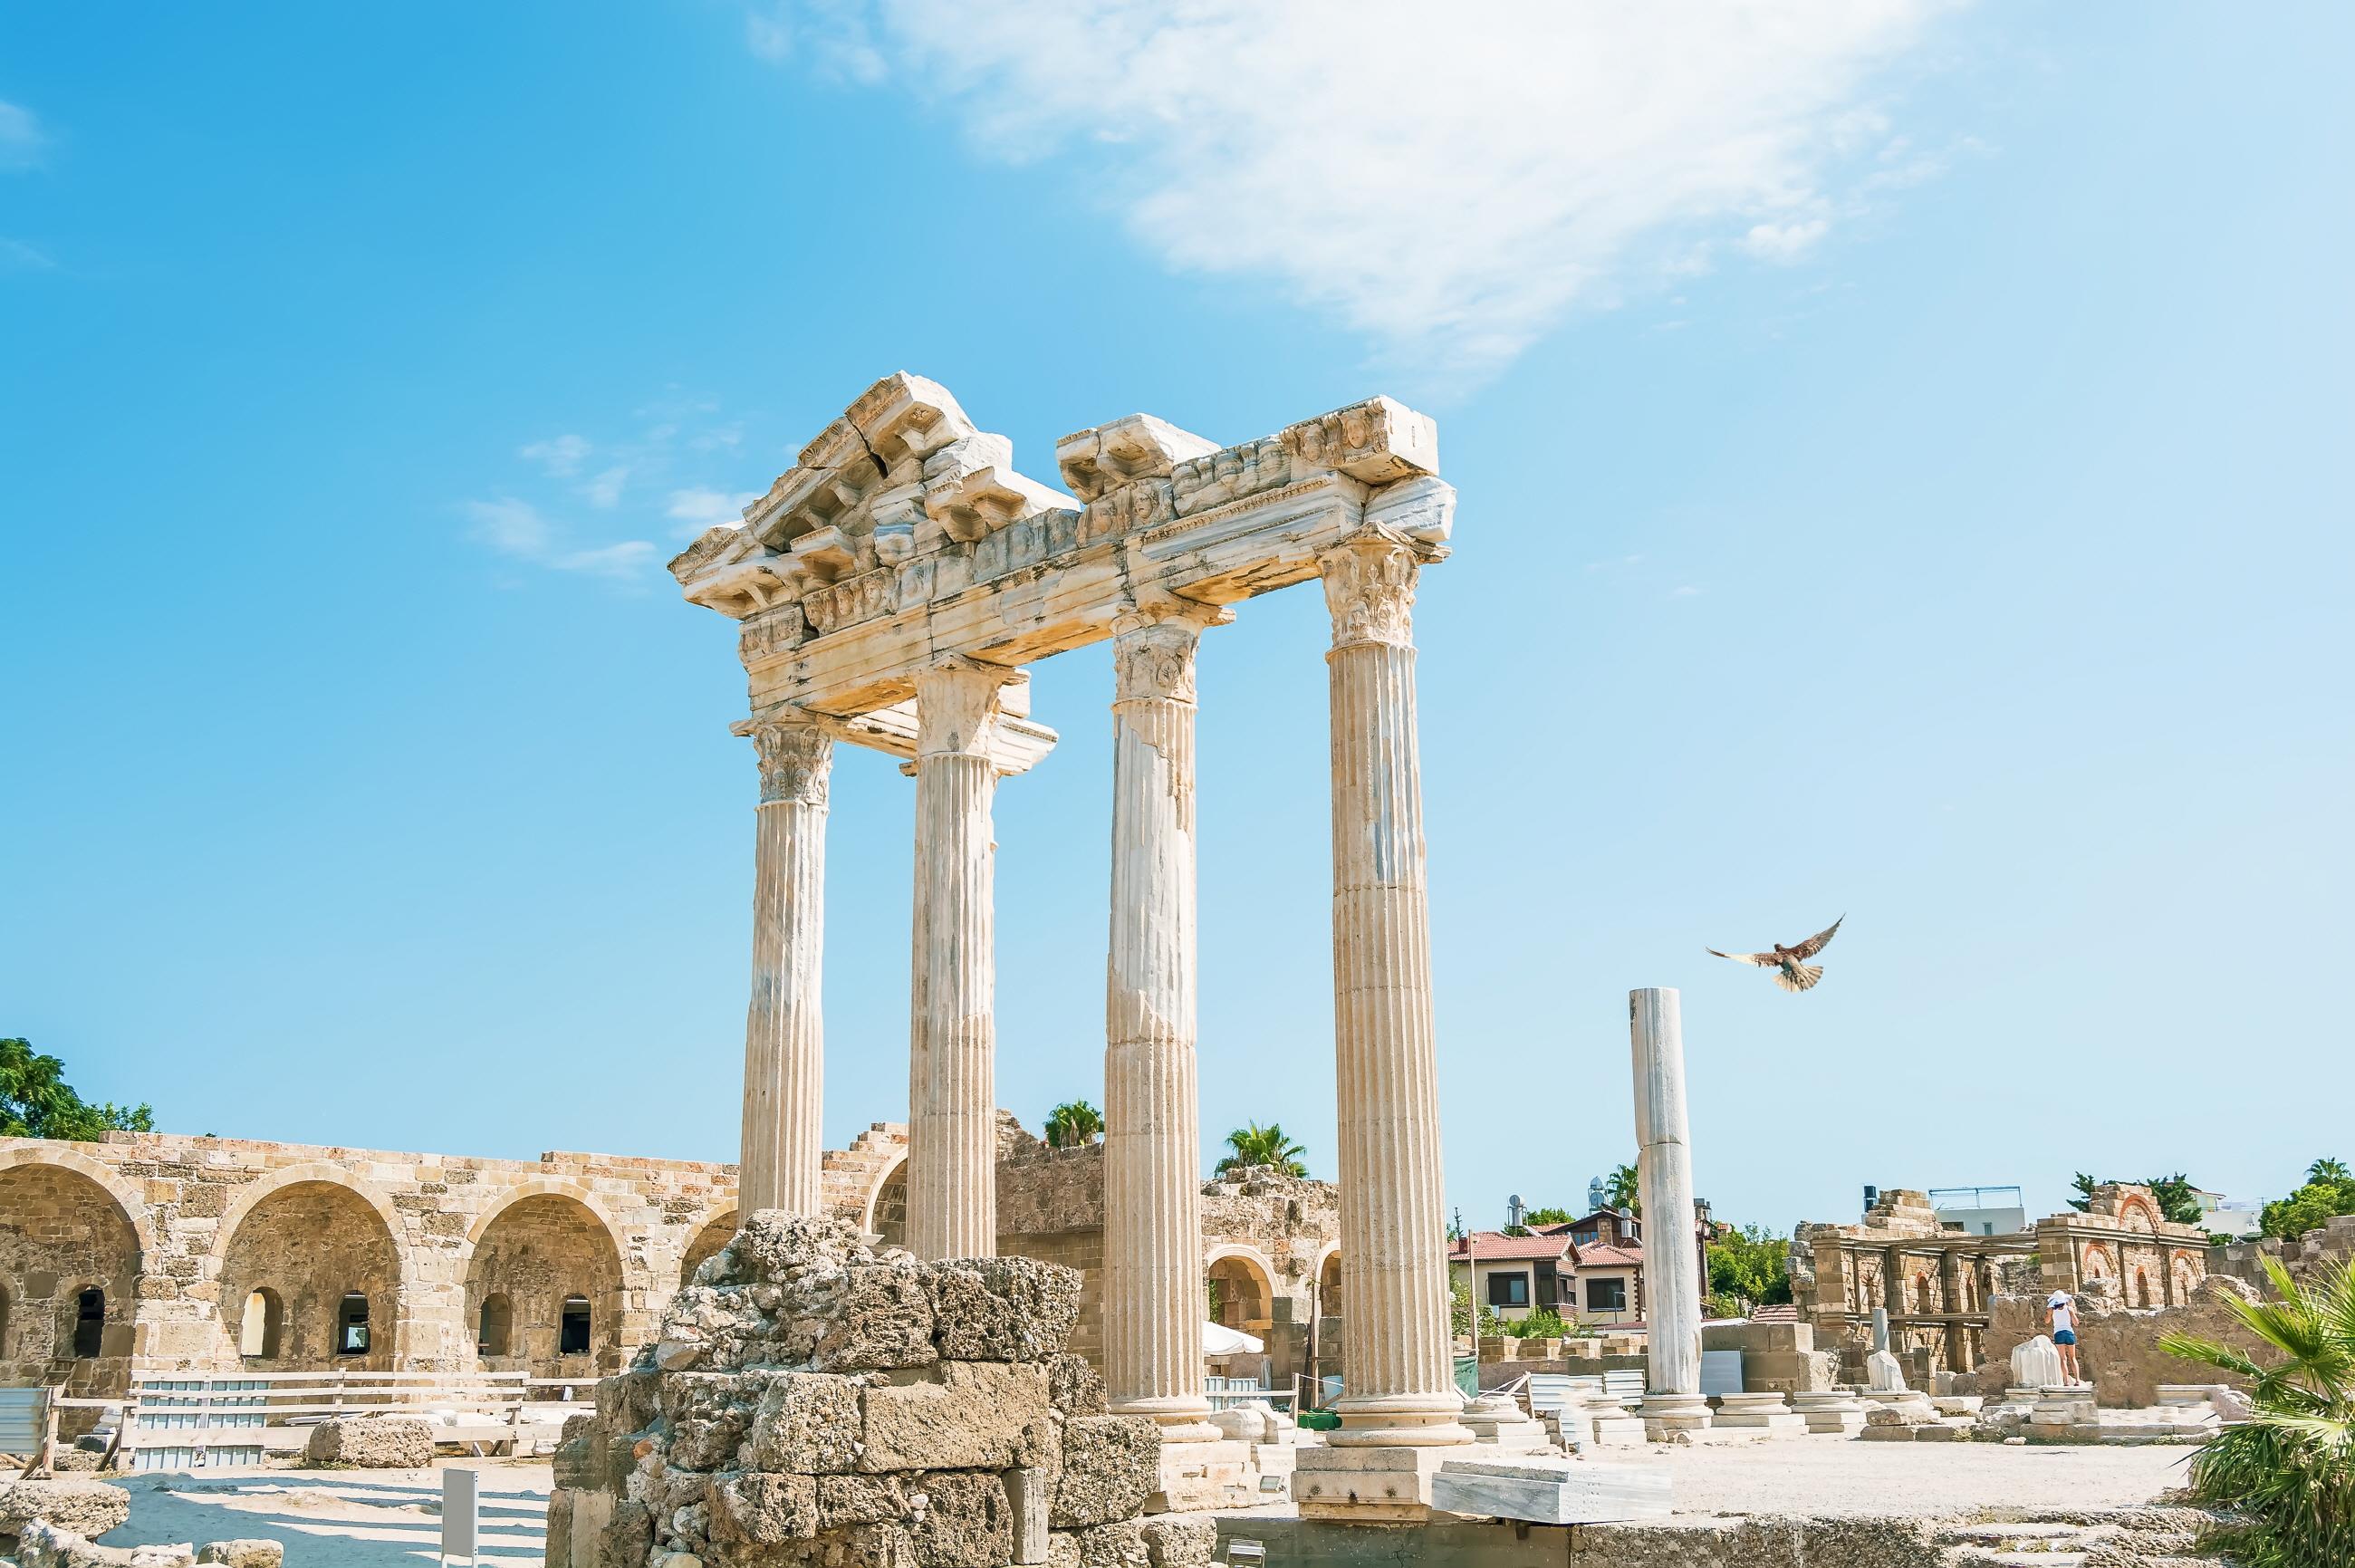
[0,1151,150,1393]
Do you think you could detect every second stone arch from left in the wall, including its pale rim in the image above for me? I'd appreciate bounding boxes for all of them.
[215,1163,415,1372]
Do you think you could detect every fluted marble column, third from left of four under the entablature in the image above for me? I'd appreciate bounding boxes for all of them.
[1104,612,1217,1441]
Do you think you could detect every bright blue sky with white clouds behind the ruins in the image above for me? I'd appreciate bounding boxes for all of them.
[0,0,2355,1227]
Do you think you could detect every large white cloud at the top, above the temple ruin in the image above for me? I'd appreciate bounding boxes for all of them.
[749,0,1950,370]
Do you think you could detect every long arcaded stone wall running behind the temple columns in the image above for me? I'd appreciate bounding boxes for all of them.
[0,1113,1338,1394]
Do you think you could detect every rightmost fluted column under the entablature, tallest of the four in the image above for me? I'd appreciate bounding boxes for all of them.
[1319,527,1472,1446]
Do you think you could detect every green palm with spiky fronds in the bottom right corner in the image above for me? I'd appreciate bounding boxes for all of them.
[2159,1257,2355,1568]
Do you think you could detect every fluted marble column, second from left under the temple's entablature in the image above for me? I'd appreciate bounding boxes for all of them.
[907,657,1013,1260]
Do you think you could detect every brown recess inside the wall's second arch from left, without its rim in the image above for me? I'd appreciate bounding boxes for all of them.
[219,1179,403,1372]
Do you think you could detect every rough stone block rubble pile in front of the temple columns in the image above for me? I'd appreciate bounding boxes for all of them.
[546,1210,1196,1568]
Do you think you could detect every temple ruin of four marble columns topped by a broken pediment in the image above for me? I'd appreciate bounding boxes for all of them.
[671,374,1472,1505]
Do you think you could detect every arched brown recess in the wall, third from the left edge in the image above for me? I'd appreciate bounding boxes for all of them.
[466,1191,621,1380]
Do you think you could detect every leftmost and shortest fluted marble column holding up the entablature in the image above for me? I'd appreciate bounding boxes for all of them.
[737,718,833,1217]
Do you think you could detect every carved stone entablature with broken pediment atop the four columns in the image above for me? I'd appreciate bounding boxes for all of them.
[671,374,1456,718]
